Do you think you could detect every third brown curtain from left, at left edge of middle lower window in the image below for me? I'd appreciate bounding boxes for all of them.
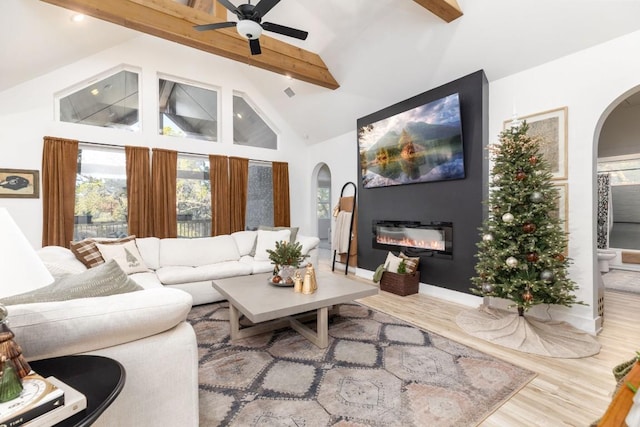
[151,148,178,238]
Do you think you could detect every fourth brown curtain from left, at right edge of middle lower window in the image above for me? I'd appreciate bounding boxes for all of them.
[209,155,231,236]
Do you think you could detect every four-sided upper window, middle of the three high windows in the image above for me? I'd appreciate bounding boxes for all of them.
[159,79,218,141]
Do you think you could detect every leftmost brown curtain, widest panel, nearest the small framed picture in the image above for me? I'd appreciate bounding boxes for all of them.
[42,136,78,248]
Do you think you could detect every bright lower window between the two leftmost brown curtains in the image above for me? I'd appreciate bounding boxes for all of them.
[74,148,127,240]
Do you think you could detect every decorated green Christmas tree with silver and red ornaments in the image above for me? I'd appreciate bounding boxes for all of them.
[471,122,582,316]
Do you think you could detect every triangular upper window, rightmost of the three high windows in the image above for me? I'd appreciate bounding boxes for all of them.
[233,95,278,150]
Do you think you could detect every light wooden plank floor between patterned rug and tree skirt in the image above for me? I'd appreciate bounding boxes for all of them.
[322,269,640,427]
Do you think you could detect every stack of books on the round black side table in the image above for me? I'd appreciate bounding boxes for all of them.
[0,373,87,427]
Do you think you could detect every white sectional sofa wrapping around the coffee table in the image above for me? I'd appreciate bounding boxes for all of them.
[7,230,319,427]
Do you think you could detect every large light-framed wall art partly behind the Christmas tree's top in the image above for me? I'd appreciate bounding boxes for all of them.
[504,107,568,180]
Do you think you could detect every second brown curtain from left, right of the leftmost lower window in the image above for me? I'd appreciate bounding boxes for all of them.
[124,146,152,237]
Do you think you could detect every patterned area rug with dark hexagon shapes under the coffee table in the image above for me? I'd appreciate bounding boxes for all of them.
[189,302,535,427]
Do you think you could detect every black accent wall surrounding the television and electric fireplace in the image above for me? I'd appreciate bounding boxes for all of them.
[356,70,489,293]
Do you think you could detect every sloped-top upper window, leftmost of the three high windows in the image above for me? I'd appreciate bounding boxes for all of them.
[60,71,139,131]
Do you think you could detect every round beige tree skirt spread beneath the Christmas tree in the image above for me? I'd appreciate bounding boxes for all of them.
[456,305,600,359]
